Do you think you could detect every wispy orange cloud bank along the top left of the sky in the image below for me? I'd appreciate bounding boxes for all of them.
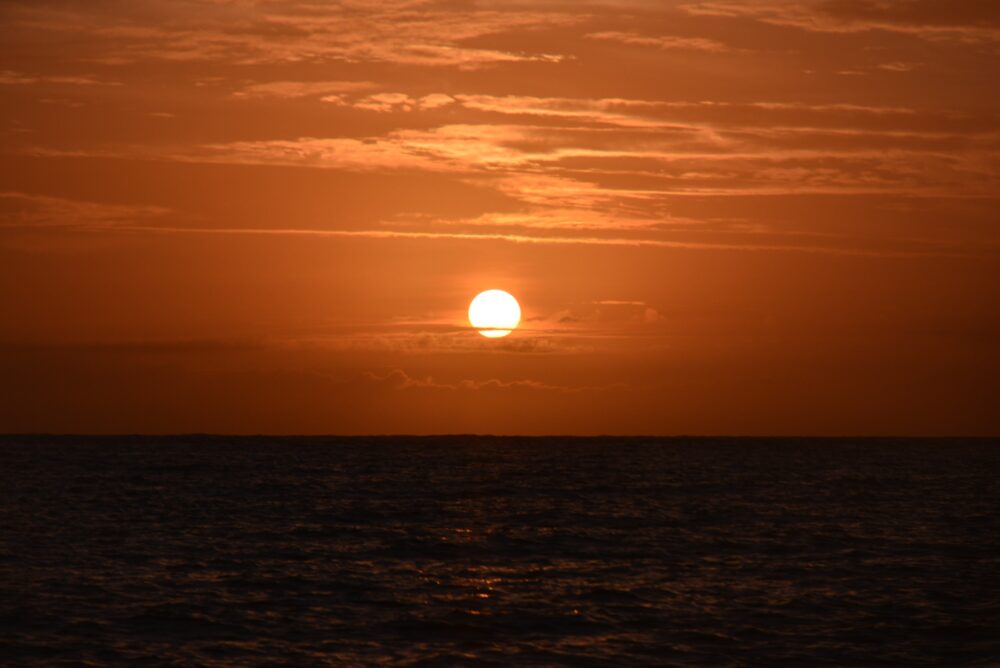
[12,1,580,70]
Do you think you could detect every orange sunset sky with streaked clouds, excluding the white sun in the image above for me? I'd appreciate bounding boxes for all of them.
[0,0,1000,435]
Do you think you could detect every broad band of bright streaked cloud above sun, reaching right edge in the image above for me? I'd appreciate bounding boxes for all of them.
[25,93,1000,205]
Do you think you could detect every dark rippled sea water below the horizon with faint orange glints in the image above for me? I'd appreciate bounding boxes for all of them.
[0,437,1000,666]
